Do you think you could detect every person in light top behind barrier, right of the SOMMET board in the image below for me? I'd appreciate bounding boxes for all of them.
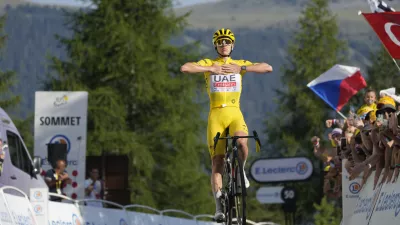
[85,168,103,207]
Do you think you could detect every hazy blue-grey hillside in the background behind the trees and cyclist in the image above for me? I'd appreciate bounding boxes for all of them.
[0,0,390,143]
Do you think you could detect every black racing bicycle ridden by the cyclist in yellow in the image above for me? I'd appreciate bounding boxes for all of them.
[214,128,261,225]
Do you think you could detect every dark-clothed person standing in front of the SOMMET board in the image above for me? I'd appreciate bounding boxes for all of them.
[45,159,72,202]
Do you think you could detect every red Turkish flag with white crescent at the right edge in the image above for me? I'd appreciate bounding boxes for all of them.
[363,12,400,59]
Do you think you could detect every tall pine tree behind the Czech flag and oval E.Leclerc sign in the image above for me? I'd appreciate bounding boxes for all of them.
[266,0,346,221]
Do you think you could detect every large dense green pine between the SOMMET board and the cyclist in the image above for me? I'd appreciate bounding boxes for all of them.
[47,0,214,213]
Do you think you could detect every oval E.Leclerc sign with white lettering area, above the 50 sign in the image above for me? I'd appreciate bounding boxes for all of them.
[250,157,313,183]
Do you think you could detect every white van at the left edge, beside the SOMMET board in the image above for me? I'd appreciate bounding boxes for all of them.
[0,108,47,196]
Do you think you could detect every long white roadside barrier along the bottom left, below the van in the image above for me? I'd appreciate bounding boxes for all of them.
[0,186,276,225]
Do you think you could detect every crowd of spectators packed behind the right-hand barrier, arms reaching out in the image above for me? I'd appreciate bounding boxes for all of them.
[311,88,400,198]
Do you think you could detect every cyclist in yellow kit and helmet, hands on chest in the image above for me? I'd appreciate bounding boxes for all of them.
[181,28,272,222]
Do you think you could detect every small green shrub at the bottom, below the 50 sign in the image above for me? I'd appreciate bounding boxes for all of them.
[314,196,342,225]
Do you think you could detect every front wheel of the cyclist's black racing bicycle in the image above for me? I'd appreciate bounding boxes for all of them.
[231,157,246,225]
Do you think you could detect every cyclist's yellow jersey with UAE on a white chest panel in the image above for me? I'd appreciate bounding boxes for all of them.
[196,57,256,109]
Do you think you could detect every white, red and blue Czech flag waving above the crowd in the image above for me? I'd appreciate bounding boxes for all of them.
[307,64,367,111]
